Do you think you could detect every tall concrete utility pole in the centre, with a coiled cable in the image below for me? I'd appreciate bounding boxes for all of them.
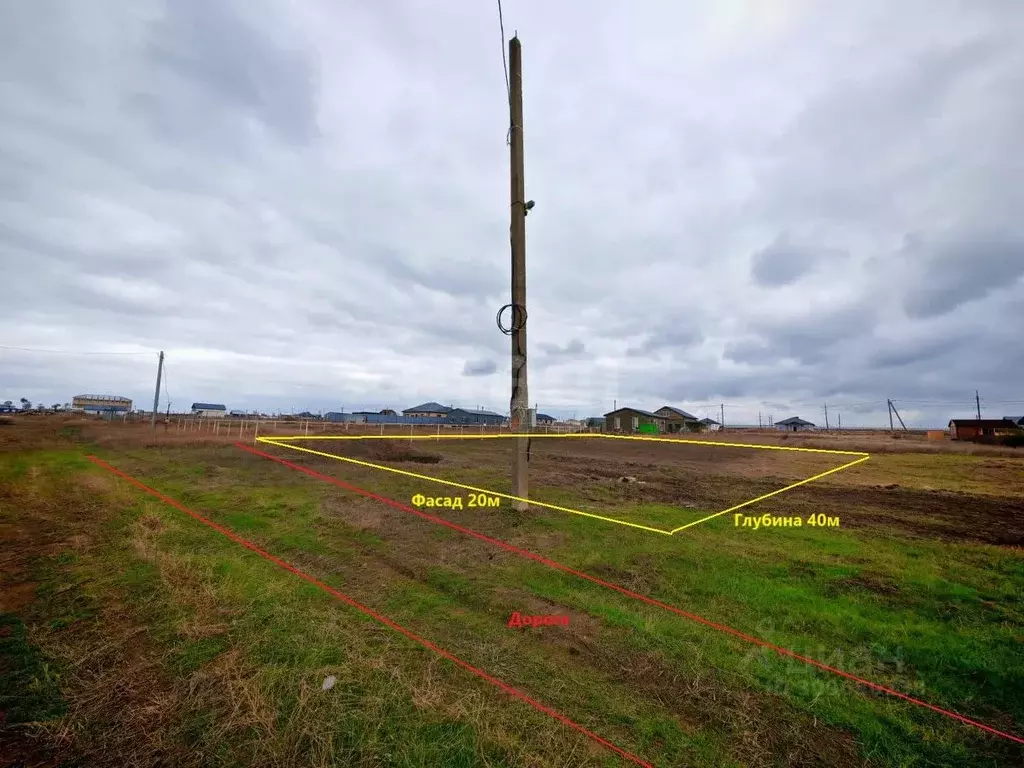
[509,37,529,510]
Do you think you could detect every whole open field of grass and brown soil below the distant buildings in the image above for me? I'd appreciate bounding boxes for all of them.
[0,419,1024,767]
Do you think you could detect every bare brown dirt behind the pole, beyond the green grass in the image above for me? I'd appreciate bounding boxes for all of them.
[301,438,1024,547]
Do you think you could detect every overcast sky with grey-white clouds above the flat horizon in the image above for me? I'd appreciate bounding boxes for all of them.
[0,0,1024,425]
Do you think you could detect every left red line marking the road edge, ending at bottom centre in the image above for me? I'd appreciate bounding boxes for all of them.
[88,456,654,768]
